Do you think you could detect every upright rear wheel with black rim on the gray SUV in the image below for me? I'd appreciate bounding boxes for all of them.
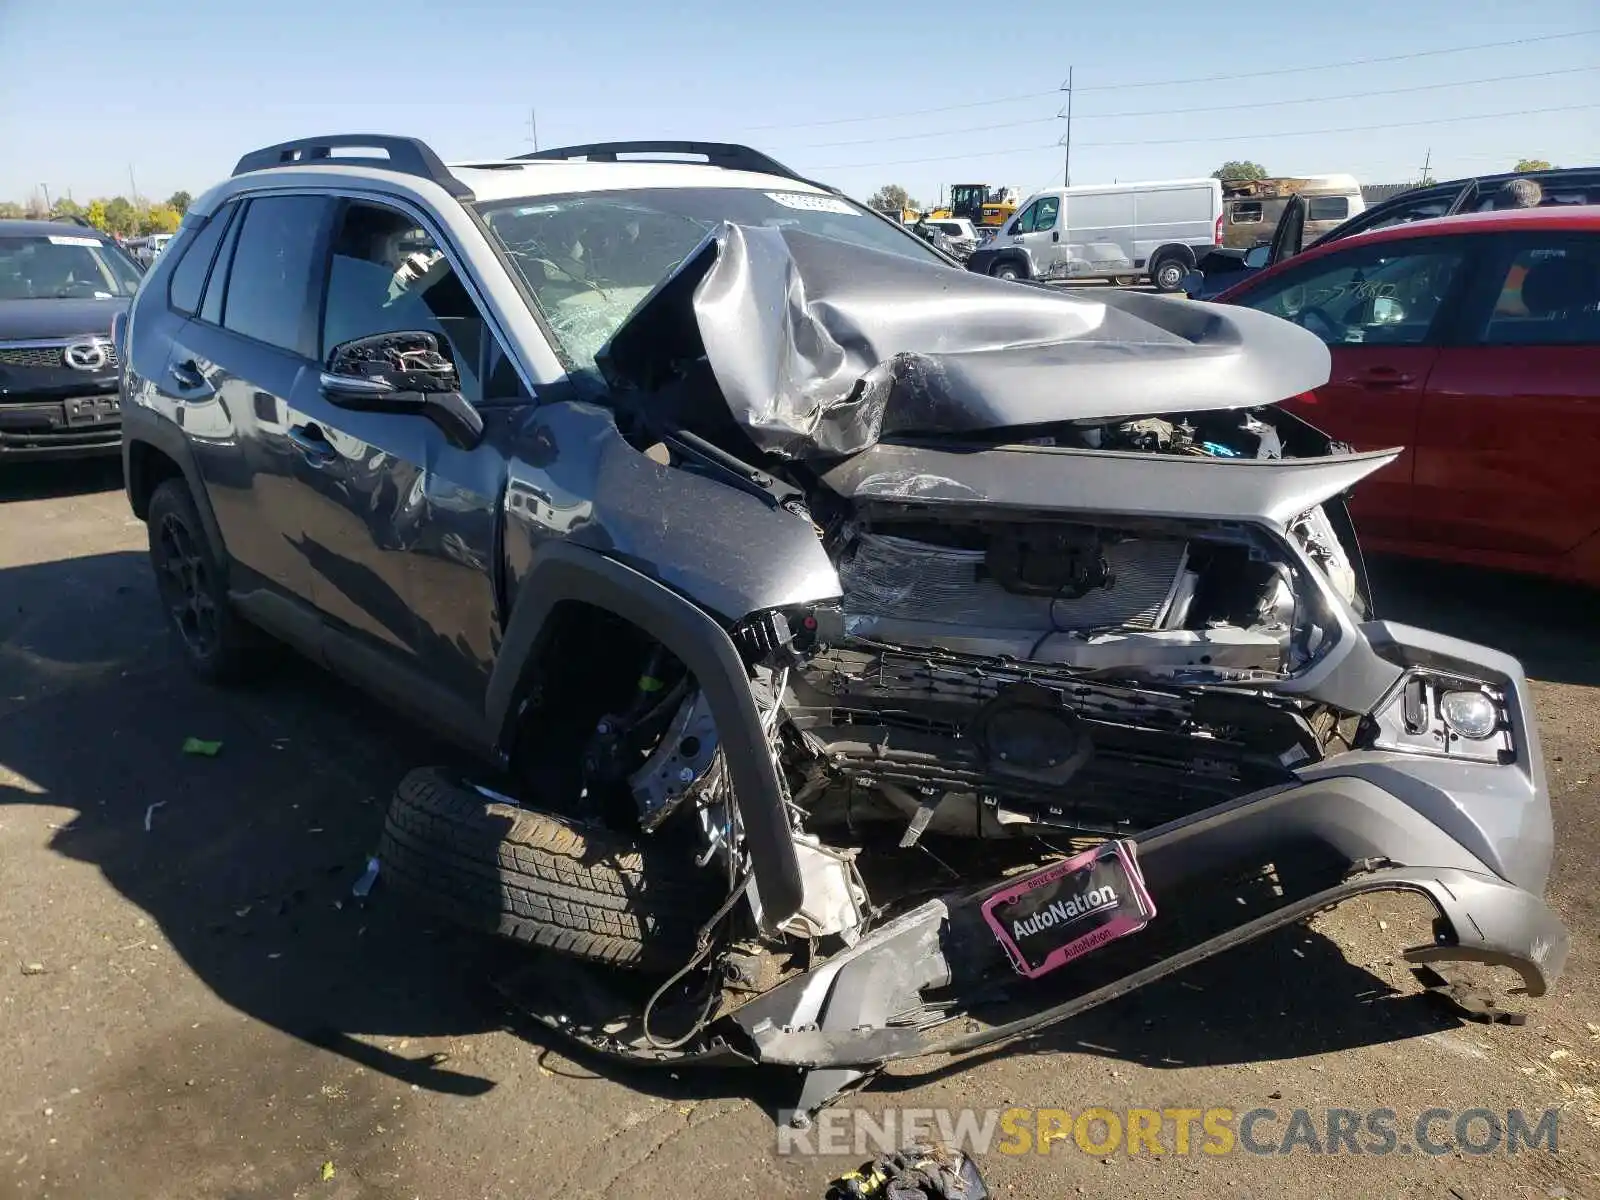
[146,478,261,683]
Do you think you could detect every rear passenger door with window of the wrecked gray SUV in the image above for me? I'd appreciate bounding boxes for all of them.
[168,195,333,620]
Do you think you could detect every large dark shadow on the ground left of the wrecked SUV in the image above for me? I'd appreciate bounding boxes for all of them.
[0,552,496,1094]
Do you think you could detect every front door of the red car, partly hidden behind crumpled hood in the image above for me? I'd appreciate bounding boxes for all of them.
[1229,238,1464,541]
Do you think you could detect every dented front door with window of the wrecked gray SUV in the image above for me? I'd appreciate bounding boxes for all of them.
[294,200,512,734]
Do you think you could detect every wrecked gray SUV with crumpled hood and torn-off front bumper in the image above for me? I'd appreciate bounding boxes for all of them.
[115,136,1568,1122]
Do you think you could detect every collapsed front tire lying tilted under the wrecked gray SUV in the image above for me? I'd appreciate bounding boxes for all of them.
[378,768,726,970]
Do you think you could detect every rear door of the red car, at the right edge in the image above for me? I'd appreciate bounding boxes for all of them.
[1416,232,1600,558]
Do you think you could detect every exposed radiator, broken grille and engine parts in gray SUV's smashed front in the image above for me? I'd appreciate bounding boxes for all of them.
[582,401,1365,960]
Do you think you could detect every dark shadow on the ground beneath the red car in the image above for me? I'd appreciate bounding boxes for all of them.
[1368,557,1600,686]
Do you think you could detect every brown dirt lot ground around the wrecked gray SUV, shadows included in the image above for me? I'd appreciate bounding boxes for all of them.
[0,467,1600,1200]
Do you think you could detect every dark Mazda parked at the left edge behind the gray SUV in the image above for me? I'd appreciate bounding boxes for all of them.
[0,221,139,459]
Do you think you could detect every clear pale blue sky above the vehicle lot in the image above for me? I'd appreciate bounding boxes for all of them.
[0,0,1600,209]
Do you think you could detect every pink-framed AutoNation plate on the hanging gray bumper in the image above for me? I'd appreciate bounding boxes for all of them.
[982,840,1155,979]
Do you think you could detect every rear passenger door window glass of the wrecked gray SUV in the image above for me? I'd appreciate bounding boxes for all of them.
[222,195,331,357]
